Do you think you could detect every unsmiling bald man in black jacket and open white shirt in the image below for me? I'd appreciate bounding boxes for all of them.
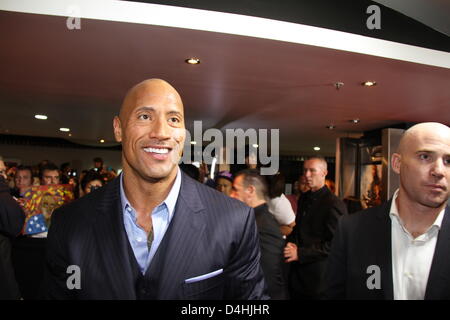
[326,123,450,300]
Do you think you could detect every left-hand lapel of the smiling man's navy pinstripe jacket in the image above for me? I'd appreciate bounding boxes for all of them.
[90,178,136,299]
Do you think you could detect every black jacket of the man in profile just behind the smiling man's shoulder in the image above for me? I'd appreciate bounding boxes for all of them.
[255,204,289,300]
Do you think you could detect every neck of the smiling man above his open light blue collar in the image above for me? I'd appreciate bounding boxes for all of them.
[123,168,178,215]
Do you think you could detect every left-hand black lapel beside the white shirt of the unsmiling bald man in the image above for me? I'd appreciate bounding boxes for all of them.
[374,201,394,300]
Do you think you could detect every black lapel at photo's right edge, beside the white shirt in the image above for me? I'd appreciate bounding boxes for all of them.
[425,207,450,299]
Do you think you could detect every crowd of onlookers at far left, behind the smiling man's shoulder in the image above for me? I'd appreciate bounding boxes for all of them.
[0,157,117,299]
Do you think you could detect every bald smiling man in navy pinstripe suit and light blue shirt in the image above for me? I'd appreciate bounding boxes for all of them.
[45,79,267,300]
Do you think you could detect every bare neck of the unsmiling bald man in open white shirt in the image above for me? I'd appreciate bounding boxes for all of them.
[395,189,446,238]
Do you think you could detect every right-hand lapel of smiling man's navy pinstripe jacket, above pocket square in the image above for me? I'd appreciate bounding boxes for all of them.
[147,173,205,299]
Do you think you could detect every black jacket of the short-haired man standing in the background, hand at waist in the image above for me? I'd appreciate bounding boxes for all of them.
[288,186,347,299]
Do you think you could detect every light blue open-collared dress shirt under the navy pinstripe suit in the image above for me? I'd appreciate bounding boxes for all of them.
[120,168,181,274]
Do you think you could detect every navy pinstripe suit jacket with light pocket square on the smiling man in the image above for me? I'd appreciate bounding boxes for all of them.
[45,174,266,299]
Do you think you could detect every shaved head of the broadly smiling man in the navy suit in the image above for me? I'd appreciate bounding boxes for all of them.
[113,79,186,183]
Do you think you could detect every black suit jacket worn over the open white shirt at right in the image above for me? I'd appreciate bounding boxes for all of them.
[326,201,450,300]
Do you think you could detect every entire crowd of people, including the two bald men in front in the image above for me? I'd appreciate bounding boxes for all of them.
[0,79,450,300]
